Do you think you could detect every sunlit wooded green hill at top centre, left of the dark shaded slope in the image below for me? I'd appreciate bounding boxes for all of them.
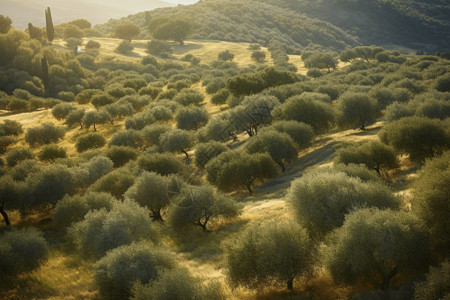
[95,0,359,51]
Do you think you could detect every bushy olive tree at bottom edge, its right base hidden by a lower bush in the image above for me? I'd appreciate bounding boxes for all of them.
[94,241,175,300]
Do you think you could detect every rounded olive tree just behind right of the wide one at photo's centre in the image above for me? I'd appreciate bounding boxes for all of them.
[245,130,298,172]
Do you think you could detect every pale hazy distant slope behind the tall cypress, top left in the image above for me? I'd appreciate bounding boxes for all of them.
[0,0,174,29]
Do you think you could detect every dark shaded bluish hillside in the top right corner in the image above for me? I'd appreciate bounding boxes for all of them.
[259,0,450,53]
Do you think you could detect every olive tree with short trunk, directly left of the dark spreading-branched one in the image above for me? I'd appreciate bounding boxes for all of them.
[125,171,170,221]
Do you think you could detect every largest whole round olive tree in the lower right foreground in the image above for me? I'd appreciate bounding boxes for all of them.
[323,208,429,291]
